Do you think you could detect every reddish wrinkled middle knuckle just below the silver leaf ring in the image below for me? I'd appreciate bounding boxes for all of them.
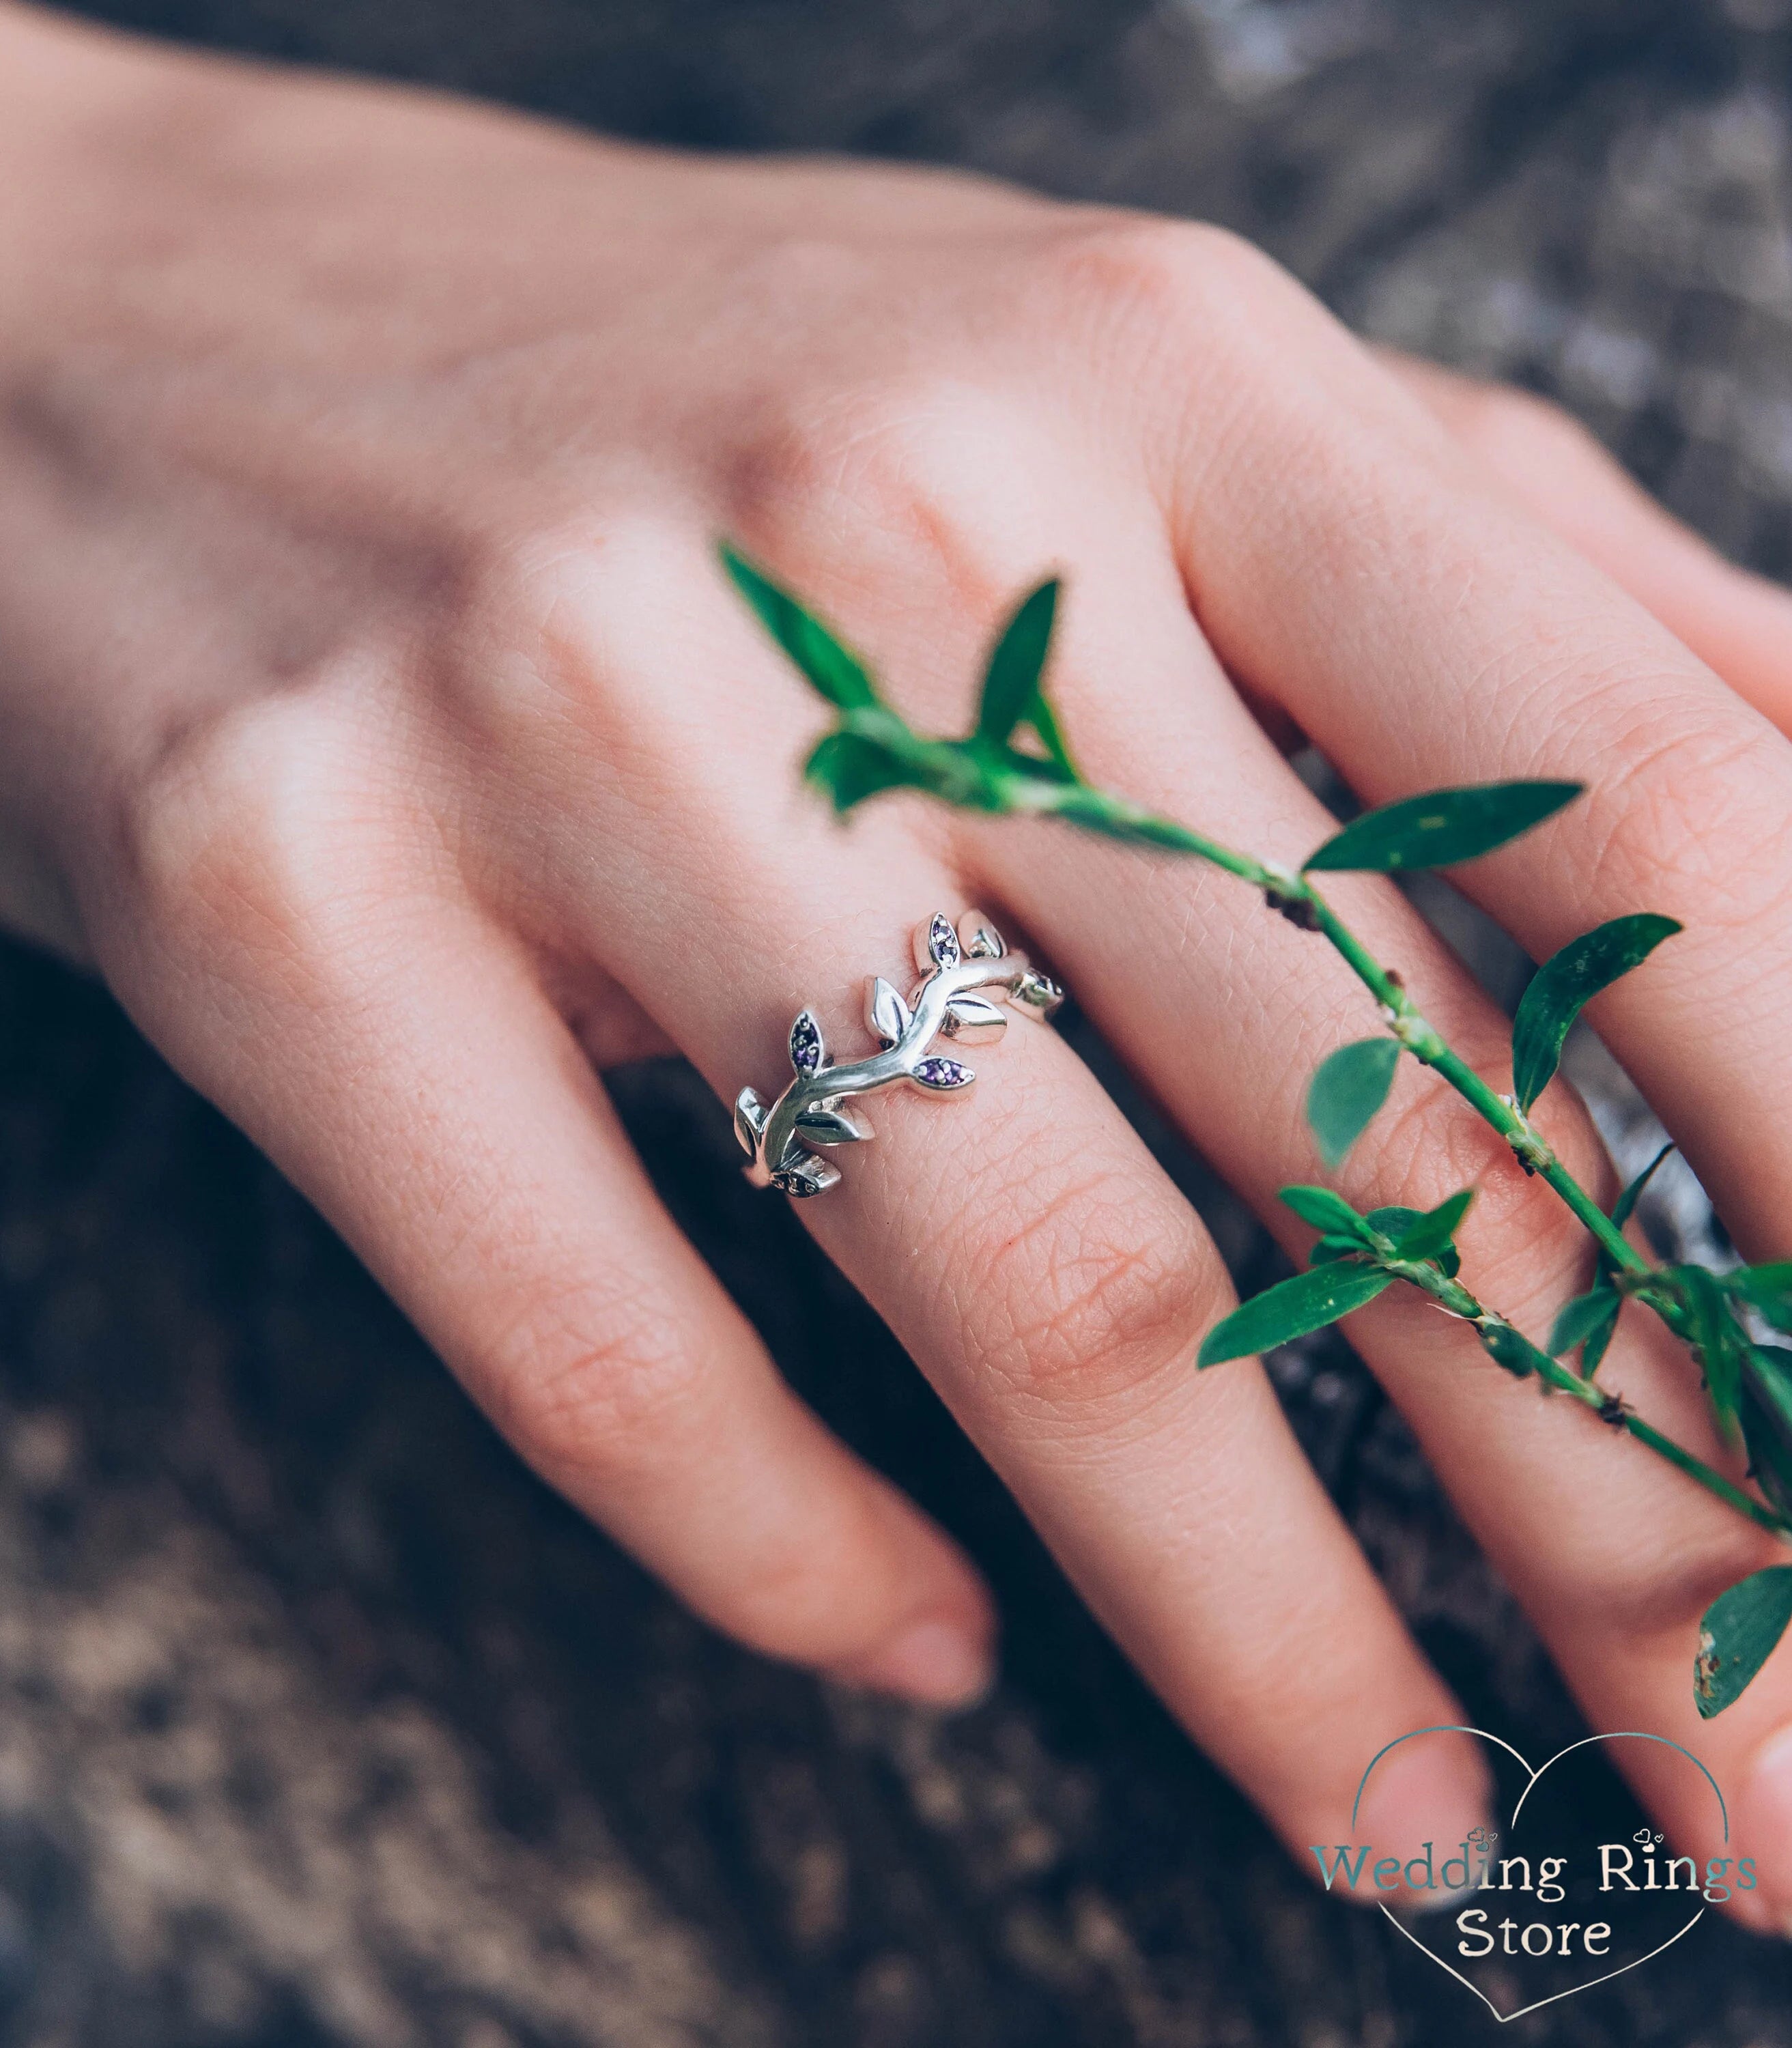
[967,1178,1229,1407]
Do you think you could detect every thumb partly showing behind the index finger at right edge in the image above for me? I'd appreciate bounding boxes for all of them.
[1380,350,1792,731]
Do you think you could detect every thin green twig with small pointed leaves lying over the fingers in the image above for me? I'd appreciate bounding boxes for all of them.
[721,545,1792,1716]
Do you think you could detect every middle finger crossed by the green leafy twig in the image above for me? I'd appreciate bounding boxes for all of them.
[946,520,1792,1913]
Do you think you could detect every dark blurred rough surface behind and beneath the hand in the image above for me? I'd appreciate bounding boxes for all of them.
[0,0,1792,2048]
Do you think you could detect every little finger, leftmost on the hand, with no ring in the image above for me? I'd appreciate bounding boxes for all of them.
[94,700,991,1700]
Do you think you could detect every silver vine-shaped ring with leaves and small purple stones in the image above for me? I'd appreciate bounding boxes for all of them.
[735,911,1063,1194]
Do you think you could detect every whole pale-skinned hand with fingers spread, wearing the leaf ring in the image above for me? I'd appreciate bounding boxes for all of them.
[0,8,1792,1927]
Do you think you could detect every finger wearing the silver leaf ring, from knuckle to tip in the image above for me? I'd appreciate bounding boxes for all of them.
[479,535,1485,1884]
